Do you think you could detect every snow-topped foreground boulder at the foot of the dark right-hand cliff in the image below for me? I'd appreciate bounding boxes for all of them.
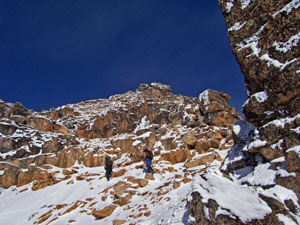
[188,168,297,225]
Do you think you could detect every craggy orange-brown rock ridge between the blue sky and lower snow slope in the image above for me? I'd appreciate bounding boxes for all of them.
[0,83,241,190]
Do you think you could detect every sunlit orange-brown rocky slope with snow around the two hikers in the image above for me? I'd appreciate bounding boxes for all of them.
[0,83,241,224]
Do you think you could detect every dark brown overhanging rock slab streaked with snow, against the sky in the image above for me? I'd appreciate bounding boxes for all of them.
[219,0,300,126]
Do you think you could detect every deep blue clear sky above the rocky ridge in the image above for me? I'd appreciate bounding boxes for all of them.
[0,0,246,114]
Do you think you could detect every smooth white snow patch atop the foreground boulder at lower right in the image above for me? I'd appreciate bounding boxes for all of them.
[189,167,272,223]
